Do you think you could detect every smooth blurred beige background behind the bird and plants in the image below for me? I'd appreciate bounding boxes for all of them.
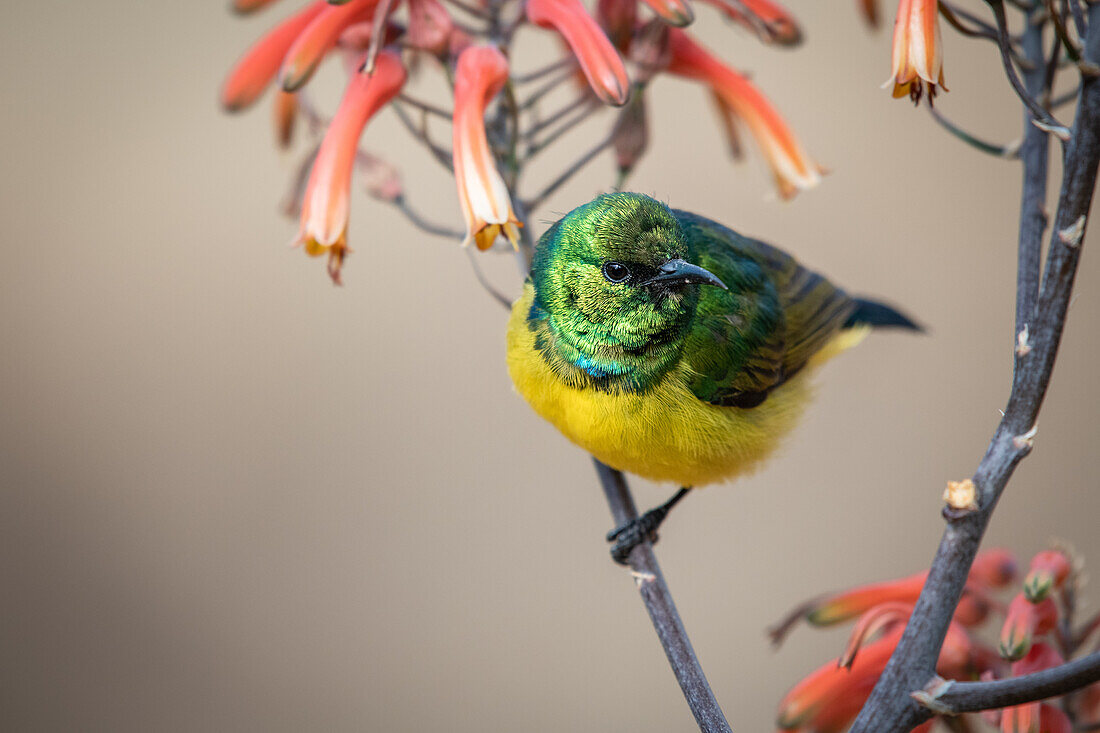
[0,0,1100,731]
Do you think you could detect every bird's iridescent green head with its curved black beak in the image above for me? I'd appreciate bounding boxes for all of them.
[528,193,725,389]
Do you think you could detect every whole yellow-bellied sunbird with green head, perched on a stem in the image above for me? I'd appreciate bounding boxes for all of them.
[507,193,920,562]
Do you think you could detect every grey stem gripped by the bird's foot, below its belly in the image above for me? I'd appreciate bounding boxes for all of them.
[593,459,730,733]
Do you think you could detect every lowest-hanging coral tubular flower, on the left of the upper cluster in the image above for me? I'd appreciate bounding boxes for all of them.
[297,51,406,280]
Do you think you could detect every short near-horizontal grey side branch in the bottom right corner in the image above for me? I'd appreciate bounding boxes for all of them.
[913,652,1100,715]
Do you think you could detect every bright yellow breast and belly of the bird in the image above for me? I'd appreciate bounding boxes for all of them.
[508,284,865,486]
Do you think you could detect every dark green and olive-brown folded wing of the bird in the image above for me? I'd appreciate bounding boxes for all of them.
[674,211,856,407]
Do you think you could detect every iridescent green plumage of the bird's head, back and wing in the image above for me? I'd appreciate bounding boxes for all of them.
[528,193,857,407]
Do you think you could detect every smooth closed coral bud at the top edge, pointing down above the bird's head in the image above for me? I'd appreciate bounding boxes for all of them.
[527,0,630,107]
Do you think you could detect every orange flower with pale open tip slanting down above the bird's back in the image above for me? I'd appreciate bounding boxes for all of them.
[669,29,818,197]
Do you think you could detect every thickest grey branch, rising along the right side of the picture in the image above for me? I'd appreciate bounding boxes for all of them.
[851,3,1100,733]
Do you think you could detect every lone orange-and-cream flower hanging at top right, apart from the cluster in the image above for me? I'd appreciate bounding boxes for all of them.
[882,0,947,103]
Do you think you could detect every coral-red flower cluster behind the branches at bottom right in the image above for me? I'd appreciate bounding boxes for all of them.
[772,548,1100,733]
